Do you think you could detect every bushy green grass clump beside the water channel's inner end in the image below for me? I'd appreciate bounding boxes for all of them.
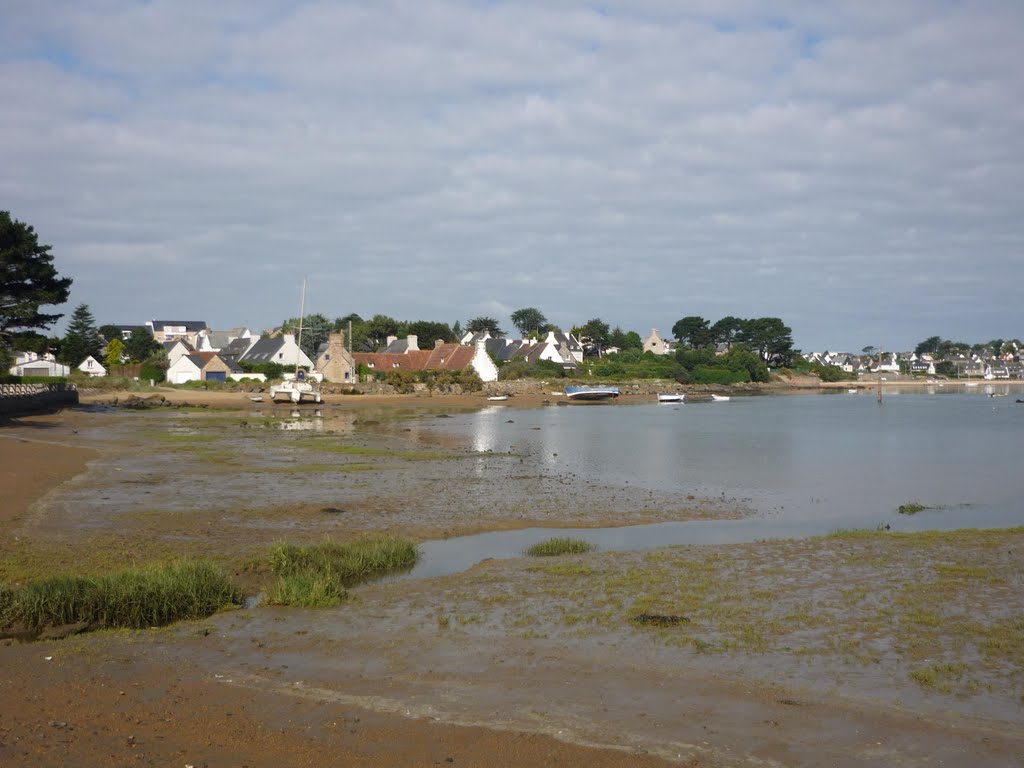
[267,537,420,607]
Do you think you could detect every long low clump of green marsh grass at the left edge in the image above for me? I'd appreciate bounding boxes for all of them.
[0,560,242,631]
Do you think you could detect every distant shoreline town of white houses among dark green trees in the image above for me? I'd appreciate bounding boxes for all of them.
[7,305,1024,391]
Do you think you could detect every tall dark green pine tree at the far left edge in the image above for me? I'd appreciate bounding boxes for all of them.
[0,211,72,346]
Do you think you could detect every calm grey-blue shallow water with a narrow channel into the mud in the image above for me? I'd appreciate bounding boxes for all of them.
[406,391,1024,578]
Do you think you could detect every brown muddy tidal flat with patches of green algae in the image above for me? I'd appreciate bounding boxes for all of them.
[0,405,1024,766]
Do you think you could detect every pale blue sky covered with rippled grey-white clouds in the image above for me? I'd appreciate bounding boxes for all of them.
[0,0,1024,352]
